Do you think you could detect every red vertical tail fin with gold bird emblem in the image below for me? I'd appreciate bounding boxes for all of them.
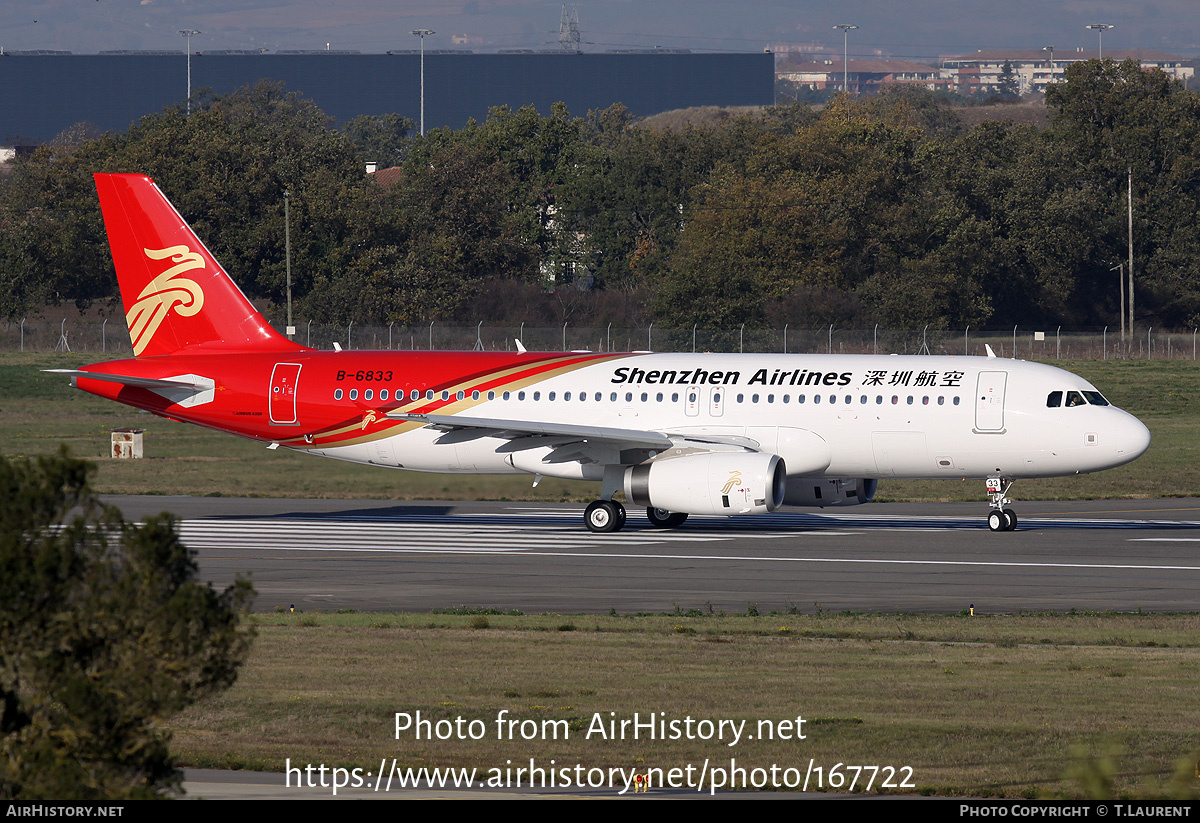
[95,174,304,356]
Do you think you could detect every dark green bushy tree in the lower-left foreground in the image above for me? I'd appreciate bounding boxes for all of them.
[0,450,253,800]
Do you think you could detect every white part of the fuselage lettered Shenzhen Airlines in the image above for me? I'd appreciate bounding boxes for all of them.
[312,354,1150,480]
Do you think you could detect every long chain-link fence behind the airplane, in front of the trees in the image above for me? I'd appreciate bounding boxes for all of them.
[0,318,1198,360]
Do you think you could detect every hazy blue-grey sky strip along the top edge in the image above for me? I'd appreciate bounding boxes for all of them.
[0,0,1200,61]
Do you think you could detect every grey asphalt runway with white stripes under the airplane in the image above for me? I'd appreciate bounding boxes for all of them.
[107,497,1200,613]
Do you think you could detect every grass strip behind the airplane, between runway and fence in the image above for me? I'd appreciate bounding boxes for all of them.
[0,353,1200,501]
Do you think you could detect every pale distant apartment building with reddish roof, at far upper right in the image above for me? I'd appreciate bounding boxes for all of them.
[945,47,1193,95]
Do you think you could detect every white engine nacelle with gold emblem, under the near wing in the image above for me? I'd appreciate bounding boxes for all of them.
[625,451,787,515]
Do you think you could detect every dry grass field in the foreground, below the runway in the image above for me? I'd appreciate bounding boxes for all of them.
[173,613,1200,798]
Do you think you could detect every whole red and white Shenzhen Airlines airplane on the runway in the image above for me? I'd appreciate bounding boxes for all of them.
[48,174,1150,533]
